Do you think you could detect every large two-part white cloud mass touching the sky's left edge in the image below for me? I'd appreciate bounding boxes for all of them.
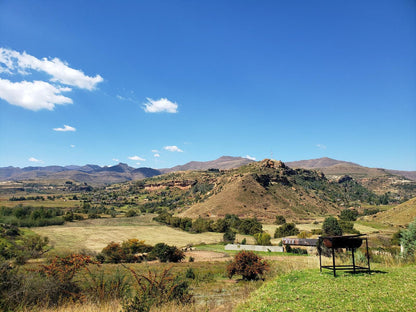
[0,48,103,111]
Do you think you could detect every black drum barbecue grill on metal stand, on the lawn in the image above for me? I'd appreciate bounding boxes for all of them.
[317,234,370,276]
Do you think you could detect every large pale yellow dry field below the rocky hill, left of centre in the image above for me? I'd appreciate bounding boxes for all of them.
[32,215,223,252]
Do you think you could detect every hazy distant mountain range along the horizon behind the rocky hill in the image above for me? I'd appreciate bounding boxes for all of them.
[0,156,416,184]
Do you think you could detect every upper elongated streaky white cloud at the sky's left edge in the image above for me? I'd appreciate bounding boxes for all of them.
[0,48,103,90]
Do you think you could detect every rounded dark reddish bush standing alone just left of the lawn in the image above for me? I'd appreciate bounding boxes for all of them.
[227,250,270,281]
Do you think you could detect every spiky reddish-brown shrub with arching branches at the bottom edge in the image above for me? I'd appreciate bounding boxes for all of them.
[123,267,192,312]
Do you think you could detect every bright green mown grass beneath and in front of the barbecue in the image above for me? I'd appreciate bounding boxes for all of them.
[236,265,416,311]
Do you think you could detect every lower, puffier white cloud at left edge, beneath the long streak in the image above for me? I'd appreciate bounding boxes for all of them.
[0,78,72,111]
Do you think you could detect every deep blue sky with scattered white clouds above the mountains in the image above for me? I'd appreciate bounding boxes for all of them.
[0,0,416,170]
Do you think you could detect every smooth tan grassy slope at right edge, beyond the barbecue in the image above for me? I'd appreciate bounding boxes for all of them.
[366,197,416,226]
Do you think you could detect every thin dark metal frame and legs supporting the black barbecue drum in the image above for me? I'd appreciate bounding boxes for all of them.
[317,234,371,277]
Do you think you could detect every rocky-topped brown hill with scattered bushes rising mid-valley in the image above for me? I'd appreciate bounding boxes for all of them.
[96,159,384,221]
